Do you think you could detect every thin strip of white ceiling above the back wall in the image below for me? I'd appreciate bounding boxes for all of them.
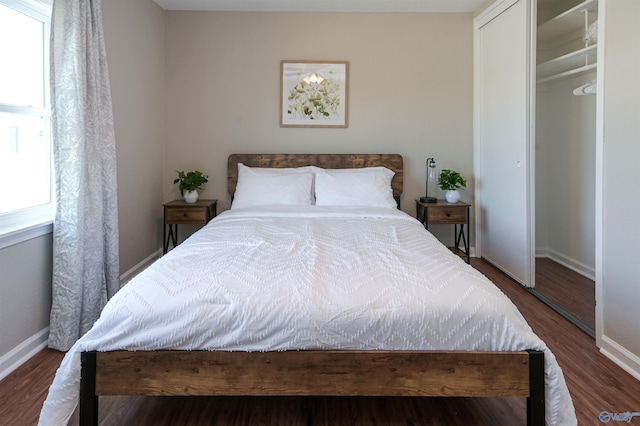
[154,0,487,12]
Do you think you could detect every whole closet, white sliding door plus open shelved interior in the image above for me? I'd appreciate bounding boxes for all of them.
[474,0,598,332]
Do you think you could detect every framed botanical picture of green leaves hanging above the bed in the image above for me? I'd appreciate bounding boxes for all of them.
[280,61,349,127]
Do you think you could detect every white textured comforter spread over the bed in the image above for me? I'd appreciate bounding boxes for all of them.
[40,206,577,425]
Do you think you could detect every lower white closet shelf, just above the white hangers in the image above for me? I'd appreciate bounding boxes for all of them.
[536,44,598,83]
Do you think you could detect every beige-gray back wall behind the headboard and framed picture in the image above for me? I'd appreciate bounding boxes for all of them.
[163,12,473,223]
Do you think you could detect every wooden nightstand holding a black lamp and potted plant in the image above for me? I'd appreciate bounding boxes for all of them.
[416,200,471,263]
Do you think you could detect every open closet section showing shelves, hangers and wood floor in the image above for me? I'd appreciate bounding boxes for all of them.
[532,0,598,336]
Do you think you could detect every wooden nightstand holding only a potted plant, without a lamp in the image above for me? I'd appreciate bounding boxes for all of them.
[162,200,218,254]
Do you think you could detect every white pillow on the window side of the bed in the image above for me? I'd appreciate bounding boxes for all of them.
[231,163,313,209]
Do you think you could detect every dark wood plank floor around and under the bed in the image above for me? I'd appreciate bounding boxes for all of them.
[0,259,640,426]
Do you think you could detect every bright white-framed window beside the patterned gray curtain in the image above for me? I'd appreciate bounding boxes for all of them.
[0,0,54,246]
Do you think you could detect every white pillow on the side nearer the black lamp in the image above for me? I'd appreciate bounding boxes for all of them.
[315,167,398,208]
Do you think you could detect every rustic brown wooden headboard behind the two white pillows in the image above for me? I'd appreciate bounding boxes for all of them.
[227,154,403,201]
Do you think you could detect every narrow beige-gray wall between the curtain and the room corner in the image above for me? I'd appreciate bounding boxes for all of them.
[102,0,166,272]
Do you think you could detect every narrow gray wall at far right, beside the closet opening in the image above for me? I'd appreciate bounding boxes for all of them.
[598,0,640,379]
